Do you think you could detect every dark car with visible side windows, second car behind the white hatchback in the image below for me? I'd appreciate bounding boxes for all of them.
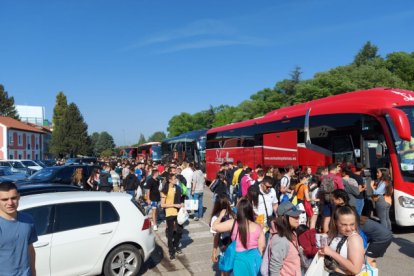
[16,165,100,185]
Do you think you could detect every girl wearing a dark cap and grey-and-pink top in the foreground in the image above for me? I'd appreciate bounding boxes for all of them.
[260,201,303,275]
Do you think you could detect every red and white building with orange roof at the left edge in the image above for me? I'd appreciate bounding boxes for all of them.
[0,116,46,159]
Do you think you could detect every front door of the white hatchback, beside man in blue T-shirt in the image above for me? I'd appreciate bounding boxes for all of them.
[23,205,53,276]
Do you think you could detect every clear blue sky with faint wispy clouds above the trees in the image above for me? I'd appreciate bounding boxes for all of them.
[0,0,414,145]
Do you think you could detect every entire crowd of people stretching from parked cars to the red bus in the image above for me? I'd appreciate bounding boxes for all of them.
[36,156,393,275]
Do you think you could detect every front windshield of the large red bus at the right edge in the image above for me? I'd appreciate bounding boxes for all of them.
[392,106,414,179]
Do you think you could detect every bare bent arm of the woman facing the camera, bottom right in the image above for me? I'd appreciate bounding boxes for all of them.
[321,235,364,275]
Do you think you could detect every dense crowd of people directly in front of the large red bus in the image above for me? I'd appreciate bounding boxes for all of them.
[210,162,393,275]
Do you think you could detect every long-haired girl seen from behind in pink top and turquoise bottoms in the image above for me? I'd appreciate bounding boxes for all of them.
[213,197,265,276]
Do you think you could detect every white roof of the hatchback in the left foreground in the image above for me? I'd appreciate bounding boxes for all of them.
[19,191,131,209]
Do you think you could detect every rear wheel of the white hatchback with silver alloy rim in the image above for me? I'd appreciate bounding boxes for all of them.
[103,244,142,276]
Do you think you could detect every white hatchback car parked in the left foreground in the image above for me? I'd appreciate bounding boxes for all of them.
[19,192,155,276]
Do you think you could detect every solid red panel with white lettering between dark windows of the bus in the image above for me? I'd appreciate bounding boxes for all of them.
[263,130,299,168]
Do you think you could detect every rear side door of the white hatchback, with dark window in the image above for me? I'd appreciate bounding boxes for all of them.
[51,201,119,276]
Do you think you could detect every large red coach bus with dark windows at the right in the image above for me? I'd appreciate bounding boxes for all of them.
[206,88,414,226]
